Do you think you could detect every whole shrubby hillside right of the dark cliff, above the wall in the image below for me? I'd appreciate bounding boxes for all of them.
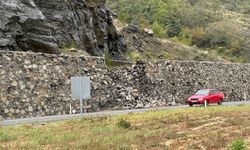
[108,0,250,63]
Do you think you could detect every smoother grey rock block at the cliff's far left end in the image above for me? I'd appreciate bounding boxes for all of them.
[0,0,58,53]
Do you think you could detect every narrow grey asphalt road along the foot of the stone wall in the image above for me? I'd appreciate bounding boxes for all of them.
[0,101,250,126]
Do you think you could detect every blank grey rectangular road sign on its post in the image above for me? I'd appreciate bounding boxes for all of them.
[71,77,91,115]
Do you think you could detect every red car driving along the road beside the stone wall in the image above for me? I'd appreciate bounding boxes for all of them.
[186,89,224,106]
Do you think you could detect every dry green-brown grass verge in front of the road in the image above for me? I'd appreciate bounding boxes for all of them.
[0,105,250,150]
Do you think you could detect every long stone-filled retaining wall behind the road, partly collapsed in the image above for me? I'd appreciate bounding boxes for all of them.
[0,52,250,119]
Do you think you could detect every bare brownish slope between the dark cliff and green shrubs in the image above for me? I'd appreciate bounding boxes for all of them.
[115,20,224,62]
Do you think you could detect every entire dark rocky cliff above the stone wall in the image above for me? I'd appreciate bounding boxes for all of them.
[0,0,126,56]
